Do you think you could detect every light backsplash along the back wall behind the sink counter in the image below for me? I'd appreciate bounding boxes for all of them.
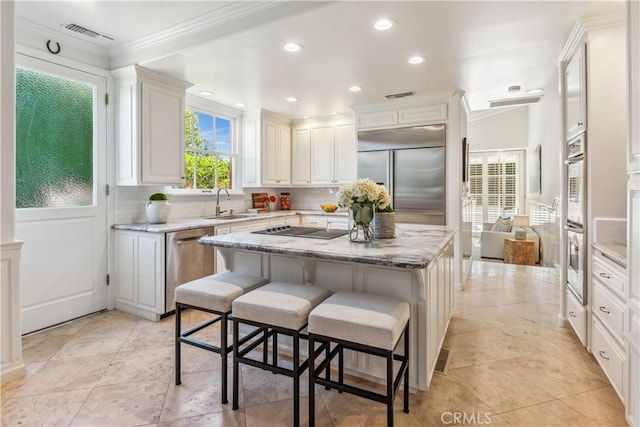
[116,185,338,224]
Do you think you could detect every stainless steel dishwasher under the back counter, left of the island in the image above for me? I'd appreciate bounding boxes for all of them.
[164,227,216,313]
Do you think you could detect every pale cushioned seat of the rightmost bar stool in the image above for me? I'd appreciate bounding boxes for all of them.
[308,291,410,350]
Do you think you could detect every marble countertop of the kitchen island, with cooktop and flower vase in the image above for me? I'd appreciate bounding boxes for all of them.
[199,224,455,269]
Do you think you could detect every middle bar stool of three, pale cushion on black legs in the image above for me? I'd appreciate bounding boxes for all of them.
[232,282,331,427]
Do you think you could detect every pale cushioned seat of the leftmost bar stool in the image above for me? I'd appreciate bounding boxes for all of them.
[175,271,269,313]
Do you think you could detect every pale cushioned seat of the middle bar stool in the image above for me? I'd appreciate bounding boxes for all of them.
[232,282,331,330]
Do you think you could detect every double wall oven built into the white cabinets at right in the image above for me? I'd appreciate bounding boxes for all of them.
[564,133,587,305]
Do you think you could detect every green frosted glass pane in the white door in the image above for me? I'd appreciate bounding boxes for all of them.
[16,67,95,209]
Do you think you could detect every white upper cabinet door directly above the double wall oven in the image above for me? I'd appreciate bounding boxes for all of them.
[564,44,587,139]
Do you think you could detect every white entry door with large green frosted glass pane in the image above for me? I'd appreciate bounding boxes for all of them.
[16,55,108,333]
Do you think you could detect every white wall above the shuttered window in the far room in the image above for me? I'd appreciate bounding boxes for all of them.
[467,106,529,151]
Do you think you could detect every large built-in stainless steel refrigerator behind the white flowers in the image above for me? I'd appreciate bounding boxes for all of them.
[358,125,446,225]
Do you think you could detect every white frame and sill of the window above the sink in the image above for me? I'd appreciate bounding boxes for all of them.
[165,94,244,196]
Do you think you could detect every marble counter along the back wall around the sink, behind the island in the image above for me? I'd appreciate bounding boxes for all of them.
[112,210,347,233]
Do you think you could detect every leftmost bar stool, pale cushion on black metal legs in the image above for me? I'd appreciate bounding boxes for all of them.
[175,272,269,403]
